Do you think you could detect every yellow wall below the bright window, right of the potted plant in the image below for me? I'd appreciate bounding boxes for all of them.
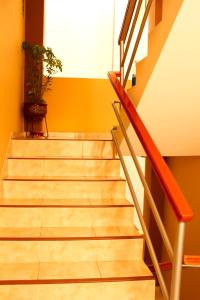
[45,78,117,132]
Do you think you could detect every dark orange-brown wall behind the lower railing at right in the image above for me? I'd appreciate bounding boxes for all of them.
[163,157,200,300]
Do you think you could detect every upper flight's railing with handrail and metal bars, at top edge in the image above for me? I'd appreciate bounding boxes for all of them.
[118,0,153,87]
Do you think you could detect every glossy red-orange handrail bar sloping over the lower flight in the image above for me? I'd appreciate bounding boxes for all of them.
[108,72,193,222]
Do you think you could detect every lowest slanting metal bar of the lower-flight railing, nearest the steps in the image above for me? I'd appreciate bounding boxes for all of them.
[111,129,169,300]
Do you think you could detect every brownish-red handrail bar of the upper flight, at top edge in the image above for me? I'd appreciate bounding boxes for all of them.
[118,0,137,45]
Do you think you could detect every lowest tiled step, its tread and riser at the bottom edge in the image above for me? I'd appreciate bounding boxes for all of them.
[0,260,155,300]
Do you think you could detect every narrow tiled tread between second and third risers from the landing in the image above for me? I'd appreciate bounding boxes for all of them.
[4,176,125,181]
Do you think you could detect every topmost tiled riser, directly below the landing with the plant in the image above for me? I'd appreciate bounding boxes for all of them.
[10,140,113,158]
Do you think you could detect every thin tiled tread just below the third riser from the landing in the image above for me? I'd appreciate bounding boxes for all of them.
[0,199,133,207]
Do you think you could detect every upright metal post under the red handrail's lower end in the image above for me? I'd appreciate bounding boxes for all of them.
[170,222,185,300]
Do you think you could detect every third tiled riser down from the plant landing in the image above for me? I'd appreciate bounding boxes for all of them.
[3,180,125,199]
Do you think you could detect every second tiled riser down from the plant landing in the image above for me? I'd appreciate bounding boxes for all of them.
[7,159,120,176]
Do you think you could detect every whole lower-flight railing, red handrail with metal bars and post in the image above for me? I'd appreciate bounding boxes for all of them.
[108,72,193,300]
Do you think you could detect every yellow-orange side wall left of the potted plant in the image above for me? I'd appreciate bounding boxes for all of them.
[0,0,24,168]
